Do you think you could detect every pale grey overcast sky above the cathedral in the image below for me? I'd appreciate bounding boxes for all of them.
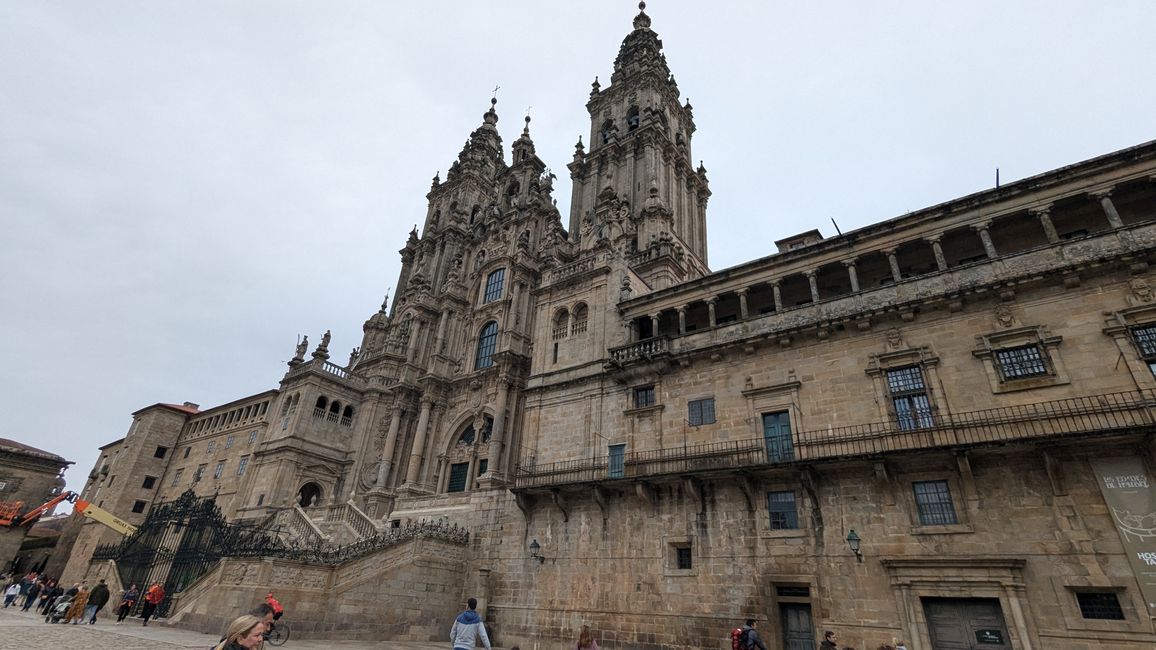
[0,0,1156,506]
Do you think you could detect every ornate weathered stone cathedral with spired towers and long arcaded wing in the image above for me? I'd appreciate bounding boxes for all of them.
[66,5,1156,650]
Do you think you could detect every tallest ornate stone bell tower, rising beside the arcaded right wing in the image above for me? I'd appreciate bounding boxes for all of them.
[569,2,711,288]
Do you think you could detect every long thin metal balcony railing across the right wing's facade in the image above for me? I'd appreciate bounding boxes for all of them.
[514,390,1156,489]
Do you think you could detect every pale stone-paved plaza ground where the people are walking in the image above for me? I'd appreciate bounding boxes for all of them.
[0,607,487,650]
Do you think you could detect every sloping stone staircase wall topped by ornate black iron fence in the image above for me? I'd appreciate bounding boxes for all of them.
[164,539,466,641]
